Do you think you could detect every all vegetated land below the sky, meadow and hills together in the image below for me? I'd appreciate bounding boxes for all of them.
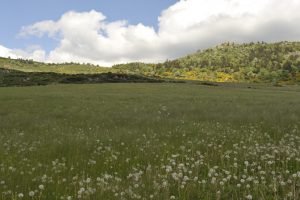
[0,42,300,200]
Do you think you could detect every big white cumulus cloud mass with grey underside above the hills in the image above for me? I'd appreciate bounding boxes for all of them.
[0,0,300,66]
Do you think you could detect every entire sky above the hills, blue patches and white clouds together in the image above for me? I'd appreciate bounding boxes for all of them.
[0,0,300,67]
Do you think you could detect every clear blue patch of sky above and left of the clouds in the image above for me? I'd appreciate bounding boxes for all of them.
[0,0,176,51]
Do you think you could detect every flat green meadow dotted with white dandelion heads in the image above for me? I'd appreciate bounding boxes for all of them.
[0,84,300,200]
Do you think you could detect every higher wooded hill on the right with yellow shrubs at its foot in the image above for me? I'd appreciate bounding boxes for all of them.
[115,42,300,83]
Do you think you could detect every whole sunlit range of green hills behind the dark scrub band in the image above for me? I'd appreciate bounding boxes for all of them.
[0,42,300,84]
